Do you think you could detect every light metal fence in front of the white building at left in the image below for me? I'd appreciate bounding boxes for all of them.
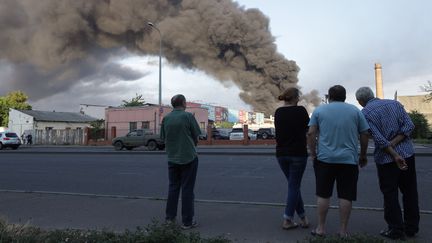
[33,129,85,145]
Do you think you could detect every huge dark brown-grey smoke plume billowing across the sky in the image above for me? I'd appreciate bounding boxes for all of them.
[0,0,320,114]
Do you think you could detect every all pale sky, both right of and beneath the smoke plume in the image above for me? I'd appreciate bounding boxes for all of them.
[0,0,432,112]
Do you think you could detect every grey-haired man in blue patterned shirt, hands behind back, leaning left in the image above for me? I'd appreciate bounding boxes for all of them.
[356,87,420,239]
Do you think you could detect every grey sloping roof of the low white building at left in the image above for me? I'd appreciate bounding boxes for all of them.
[19,110,97,122]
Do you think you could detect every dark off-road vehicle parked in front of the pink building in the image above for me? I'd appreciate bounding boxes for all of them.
[112,129,165,151]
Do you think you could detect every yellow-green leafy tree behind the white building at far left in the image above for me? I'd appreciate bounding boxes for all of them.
[0,91,32,127]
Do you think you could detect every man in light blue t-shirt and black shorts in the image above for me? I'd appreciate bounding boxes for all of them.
[308,85,369,236]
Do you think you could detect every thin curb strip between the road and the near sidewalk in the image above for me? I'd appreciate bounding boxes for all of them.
[0,189,432,215]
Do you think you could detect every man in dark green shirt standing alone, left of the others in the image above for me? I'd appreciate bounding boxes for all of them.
[160,94,201,229]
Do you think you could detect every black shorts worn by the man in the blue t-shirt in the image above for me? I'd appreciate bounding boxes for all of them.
[314,160,359,201]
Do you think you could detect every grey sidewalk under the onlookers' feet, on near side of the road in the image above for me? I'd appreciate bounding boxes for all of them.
[0,192,432,242]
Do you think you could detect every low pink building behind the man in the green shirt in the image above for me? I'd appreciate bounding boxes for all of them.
[105,104,208,139]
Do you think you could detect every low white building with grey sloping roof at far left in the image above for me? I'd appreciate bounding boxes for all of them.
[8,109,97,136]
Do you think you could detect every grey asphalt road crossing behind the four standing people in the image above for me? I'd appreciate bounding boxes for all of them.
[0,151,432,212]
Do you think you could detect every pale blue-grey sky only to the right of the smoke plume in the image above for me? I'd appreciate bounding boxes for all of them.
[238,0,432,103]
